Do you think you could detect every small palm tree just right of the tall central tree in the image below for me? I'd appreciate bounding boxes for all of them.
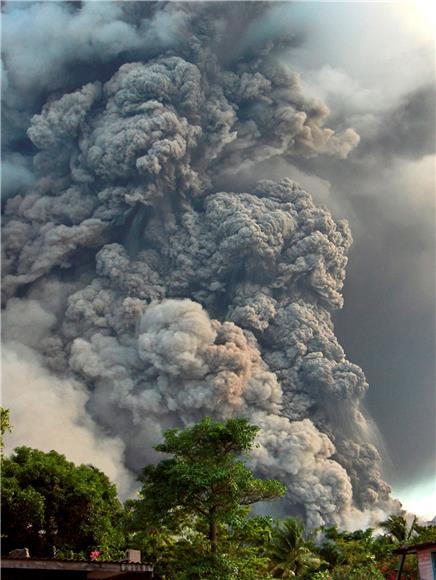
[268,518,321,578]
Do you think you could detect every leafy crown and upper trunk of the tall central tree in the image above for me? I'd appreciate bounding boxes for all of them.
[129,418,285,553]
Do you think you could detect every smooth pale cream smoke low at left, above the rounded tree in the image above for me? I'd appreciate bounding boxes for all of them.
[2,343,134,497]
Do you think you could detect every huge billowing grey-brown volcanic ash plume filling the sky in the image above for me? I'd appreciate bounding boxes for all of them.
[3,2,392,526]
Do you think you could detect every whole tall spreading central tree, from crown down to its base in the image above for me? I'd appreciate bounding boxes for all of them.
[128,418,285,578]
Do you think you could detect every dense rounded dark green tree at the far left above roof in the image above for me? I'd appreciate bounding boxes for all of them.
[2,447,123,556]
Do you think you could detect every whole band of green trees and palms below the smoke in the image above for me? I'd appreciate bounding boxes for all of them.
[1,410,436,580]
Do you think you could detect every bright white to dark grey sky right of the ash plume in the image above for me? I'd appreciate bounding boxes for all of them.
[272,2,436,515]
